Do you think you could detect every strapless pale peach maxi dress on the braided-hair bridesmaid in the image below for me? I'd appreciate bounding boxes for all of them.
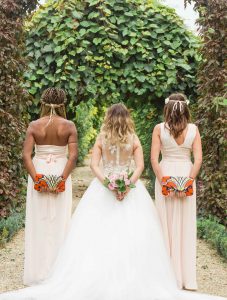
[24,145,72,285]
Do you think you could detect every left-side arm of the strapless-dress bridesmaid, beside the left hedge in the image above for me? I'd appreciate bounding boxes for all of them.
[22,123,36,181]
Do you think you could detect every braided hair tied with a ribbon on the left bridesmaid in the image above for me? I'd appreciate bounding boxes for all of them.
[40,87,66,119]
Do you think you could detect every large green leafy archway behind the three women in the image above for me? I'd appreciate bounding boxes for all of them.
[25,0,200,169]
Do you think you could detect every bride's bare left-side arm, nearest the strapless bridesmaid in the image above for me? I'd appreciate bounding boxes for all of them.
[90,137,105,183]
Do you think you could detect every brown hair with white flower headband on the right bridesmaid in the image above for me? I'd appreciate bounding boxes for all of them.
[164,93,191,138]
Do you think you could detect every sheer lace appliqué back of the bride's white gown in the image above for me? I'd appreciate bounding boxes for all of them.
[100,135,134,175]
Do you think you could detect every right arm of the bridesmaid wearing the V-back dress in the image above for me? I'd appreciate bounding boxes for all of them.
[189,128,202,179]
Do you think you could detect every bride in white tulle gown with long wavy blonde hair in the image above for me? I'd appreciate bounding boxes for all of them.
[0,104,224,300]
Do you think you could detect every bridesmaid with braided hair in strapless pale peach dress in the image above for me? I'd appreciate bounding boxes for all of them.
[23,88,77,285]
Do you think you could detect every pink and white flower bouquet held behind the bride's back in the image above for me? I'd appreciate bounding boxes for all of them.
[104,171,136,193]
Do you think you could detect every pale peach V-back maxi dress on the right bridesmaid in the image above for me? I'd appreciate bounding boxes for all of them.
[155,123,197,289]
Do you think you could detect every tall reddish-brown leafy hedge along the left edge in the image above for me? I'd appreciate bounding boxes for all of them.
[0,0,37,217]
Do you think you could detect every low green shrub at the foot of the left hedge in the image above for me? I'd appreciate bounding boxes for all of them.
[0,211,25,246]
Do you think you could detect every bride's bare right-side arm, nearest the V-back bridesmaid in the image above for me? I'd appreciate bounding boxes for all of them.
[131,137,144,183]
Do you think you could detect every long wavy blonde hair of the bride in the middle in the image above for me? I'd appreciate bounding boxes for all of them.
[101,103,135,144]
